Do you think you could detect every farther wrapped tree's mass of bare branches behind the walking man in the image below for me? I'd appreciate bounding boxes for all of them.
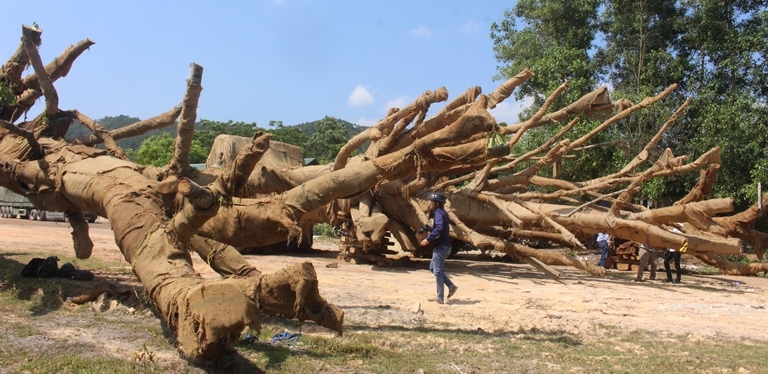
[202,76,768,275]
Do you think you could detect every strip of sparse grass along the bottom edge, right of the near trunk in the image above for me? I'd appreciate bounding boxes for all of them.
[238,322,768,373]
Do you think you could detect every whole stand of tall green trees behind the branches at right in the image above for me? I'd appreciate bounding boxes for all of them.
[491,0,768,219]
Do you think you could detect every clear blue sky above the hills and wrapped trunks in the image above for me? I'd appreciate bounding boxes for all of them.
[0,0,521,127]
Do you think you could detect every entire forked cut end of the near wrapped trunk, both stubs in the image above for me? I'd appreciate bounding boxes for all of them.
[170,262,344,361]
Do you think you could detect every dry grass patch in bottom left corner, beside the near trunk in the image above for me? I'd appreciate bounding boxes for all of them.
[0,253,184,373]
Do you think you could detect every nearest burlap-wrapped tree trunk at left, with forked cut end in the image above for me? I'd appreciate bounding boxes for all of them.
[0,27,343,359]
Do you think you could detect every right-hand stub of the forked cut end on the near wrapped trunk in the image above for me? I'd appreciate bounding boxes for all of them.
[259,262,344,335]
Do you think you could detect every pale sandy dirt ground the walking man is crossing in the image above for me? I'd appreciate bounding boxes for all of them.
[0,218,768,346]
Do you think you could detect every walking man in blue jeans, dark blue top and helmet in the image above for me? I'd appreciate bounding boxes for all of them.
[419,192,459,304]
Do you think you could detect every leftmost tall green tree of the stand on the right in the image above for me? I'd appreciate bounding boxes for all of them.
[491,0,620,183]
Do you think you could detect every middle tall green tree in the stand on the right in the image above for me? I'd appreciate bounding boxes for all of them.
[595,0,693,191]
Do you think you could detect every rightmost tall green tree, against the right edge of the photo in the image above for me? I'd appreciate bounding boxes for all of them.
[676,0,768,213]
